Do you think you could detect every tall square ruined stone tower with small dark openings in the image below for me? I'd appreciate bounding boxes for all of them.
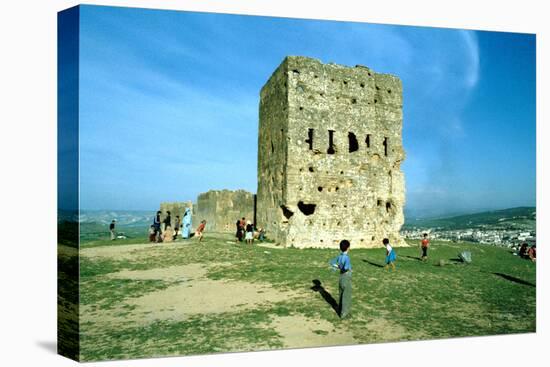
[257,56,405,248]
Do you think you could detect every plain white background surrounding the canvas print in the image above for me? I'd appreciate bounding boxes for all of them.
[0,0,550,366]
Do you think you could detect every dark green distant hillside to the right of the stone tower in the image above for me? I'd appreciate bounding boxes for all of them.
[404,207,536,229]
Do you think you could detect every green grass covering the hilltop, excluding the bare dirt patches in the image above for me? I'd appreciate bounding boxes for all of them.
[71,234,536,360]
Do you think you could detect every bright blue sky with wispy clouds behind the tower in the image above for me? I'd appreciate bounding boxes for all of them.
[75,6,536,216]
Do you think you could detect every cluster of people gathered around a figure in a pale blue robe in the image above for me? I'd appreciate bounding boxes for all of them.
[149,208,206,242]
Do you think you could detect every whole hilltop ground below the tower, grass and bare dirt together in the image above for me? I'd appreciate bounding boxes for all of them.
[58,233,536,360]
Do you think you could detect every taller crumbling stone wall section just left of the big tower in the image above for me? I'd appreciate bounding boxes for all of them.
[193,190,254,232]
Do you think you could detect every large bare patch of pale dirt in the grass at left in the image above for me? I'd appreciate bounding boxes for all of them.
[81,262,304,327]
